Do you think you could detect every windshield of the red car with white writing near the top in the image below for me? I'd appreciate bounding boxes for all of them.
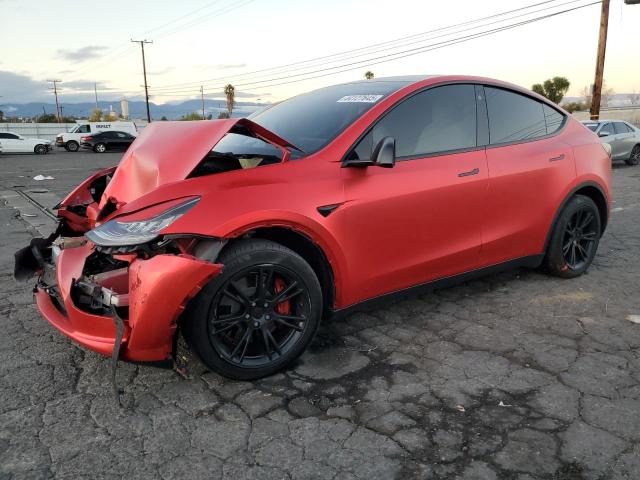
[251,80,410,158]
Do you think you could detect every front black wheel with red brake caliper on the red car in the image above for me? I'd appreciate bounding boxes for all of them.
[182,239,322,380]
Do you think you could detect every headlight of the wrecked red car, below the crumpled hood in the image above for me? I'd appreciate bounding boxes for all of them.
[85,198,200,247]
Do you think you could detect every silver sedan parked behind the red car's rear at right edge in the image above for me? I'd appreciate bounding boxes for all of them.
[582,120,640,165]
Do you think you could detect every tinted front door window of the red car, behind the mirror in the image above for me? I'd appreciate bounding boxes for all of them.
[349,85,476,159]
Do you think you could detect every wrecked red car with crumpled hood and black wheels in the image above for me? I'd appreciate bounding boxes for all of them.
[16,76,611,379]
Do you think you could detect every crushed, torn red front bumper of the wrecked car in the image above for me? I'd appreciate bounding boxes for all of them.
[16,239,222,362]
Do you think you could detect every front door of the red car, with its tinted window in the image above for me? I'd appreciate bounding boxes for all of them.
[342,84,487,301]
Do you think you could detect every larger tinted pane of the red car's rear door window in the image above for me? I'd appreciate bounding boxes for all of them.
[484,87,547,144]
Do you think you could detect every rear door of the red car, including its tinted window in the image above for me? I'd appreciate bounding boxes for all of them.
[482,86,576,264]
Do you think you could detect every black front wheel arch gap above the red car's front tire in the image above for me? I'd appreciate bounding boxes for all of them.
[218,226,336,318]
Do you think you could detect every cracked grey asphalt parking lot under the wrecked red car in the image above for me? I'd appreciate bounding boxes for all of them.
[0,150,640,480]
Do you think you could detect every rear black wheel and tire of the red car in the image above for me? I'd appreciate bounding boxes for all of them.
[545,195,601,278]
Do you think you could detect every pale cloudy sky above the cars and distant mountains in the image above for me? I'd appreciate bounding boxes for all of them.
[0,0,640,106]
